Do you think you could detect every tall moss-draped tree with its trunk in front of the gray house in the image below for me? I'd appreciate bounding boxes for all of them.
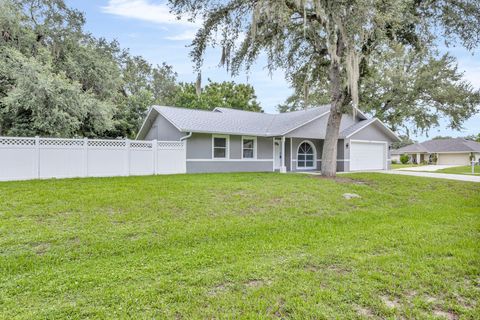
[170,0,480,176]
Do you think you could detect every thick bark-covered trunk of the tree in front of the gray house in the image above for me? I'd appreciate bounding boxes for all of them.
[322,36,347,177]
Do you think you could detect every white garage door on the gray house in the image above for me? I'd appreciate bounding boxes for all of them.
[350,141,387,171]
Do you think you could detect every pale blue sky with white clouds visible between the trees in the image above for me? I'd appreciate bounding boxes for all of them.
[66,0,480,141]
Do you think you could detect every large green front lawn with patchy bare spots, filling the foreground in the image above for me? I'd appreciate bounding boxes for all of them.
[0,173,480,319]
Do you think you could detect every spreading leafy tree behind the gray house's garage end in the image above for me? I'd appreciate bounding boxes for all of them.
[278,45,480,135]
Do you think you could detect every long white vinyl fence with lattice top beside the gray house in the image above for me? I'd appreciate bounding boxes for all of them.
[0,137,186,181]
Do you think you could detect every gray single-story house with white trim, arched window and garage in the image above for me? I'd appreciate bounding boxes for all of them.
[137,106,399,172]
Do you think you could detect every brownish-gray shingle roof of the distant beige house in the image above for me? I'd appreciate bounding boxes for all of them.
[392,138,480,154]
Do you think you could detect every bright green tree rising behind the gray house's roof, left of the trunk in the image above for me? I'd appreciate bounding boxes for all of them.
[174,79,262,112]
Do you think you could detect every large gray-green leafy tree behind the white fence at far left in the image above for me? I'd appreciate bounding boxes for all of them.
[0,0,119,137]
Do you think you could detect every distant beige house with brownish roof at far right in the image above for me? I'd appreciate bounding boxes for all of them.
[392,138,480,165]
